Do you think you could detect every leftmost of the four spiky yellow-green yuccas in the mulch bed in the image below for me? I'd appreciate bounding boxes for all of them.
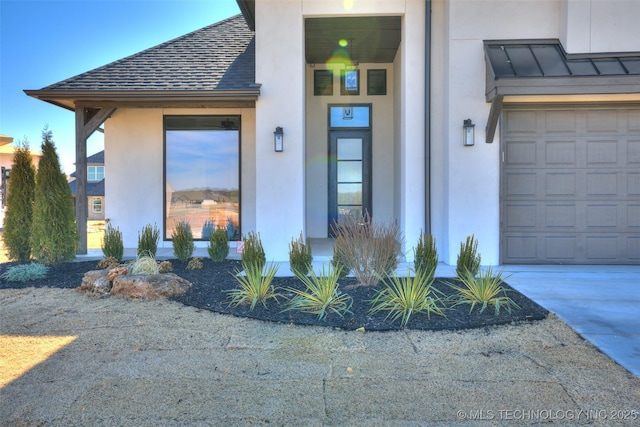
[228,262,278,310]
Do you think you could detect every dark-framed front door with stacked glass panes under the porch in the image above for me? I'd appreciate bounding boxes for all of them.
[329,129,371,236]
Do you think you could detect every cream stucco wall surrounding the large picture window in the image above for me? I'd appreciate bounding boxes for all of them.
[104,108,255,248]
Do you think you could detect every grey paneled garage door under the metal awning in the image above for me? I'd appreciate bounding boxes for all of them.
[500,106,640,264]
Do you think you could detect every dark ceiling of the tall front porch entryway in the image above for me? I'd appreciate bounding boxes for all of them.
[305,16,401,64]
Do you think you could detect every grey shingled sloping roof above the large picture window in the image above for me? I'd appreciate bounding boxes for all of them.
[25,14,259,109]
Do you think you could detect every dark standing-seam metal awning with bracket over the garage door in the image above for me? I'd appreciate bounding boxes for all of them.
[484,40,640,143]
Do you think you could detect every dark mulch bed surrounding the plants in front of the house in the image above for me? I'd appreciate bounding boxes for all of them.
[0,259,548,331]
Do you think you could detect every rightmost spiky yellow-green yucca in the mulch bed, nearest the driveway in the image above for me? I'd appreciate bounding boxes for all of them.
[449,267,520,316]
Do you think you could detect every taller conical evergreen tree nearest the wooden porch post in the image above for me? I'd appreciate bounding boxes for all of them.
[31,128,78,264]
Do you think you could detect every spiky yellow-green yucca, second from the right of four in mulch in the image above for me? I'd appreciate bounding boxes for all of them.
[370,268,445,326]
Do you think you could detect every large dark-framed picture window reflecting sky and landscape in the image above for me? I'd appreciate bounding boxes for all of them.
[164,116,240,240]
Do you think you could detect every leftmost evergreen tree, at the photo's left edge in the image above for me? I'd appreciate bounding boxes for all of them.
[3,139,36,261]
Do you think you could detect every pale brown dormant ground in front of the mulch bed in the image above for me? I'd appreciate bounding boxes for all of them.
[0,287,640,426]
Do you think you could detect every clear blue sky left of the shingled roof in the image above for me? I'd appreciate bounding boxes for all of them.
[0,0,240,173]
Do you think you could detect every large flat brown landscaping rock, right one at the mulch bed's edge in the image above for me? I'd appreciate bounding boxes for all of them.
[111,273,192,299]
